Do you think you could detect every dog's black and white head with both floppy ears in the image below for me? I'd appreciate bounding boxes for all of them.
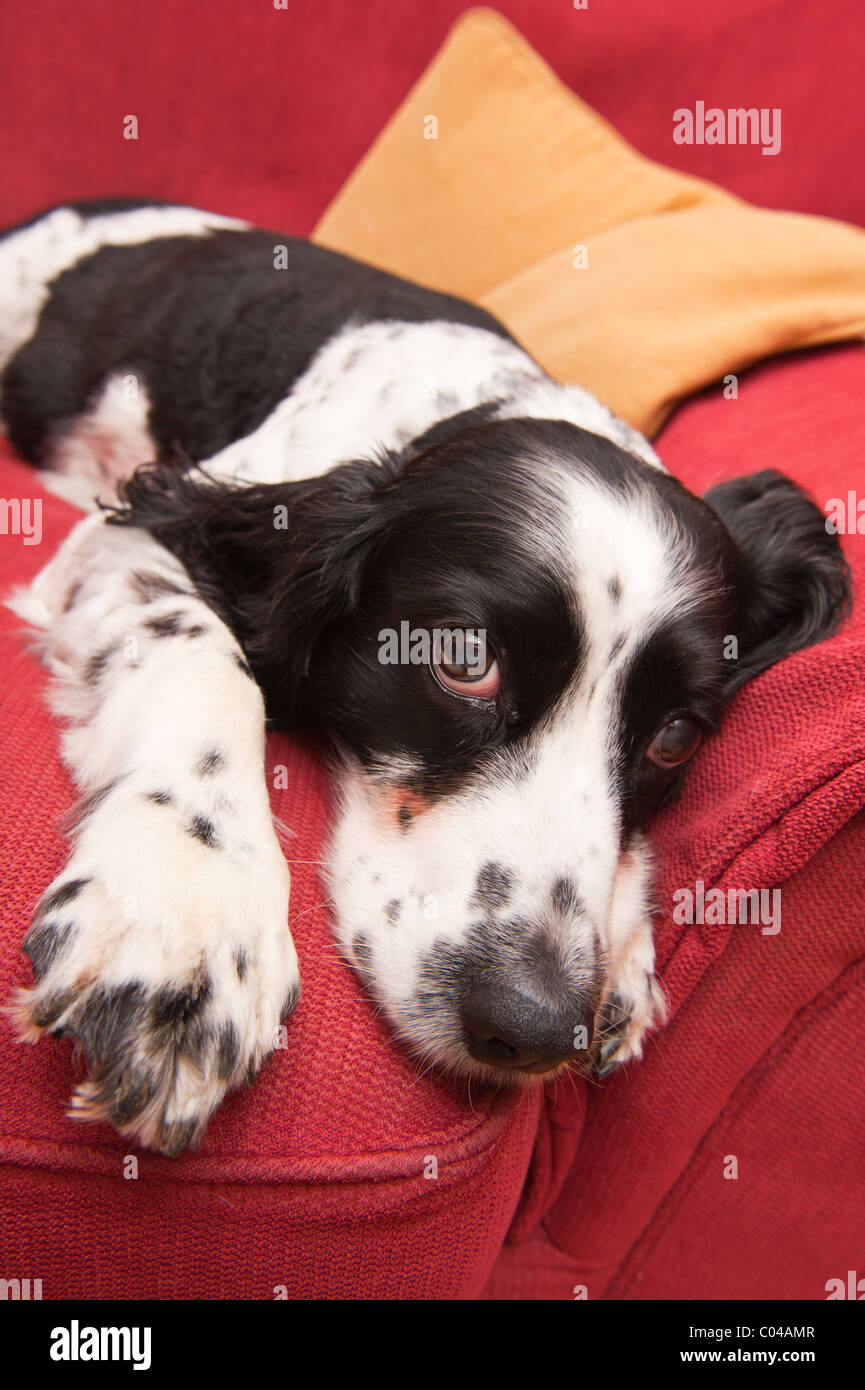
[116,420,847,1079]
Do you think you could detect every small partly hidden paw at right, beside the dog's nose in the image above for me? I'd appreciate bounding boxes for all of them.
[594,926,668,1076]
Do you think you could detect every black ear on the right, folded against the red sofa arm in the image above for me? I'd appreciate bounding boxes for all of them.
[704,468,850,695]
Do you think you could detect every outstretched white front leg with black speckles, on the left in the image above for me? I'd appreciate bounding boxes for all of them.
[6,517,299,1154]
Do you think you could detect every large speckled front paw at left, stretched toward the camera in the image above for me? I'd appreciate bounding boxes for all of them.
[10,792,300,1154]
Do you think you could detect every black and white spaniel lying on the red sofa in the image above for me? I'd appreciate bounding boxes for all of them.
[0,200,848,1154]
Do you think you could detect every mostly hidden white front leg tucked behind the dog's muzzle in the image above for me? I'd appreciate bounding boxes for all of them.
[595,835,666,1076]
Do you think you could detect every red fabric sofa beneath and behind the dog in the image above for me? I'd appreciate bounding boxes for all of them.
[0,0,865,1300]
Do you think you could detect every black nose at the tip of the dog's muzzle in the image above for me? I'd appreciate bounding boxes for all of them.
[462,979,594,1072]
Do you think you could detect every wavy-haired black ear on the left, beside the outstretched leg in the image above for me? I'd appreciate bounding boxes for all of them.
[108,455,398,723]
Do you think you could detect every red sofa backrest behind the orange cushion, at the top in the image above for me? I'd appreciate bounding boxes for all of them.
[0,0,865,234]
